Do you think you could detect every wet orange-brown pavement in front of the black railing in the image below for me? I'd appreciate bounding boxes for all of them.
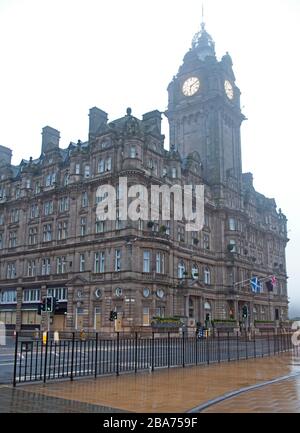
[0,352,300,413]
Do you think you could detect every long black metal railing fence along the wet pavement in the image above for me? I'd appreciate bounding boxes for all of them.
[13,331,298,386]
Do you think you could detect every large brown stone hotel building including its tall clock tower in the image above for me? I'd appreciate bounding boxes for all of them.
[0,23,288,332]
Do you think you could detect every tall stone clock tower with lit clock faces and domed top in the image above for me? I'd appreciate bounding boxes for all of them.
[166,22,245,186]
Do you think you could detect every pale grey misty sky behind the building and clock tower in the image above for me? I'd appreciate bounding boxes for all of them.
[0,0,300,315]
